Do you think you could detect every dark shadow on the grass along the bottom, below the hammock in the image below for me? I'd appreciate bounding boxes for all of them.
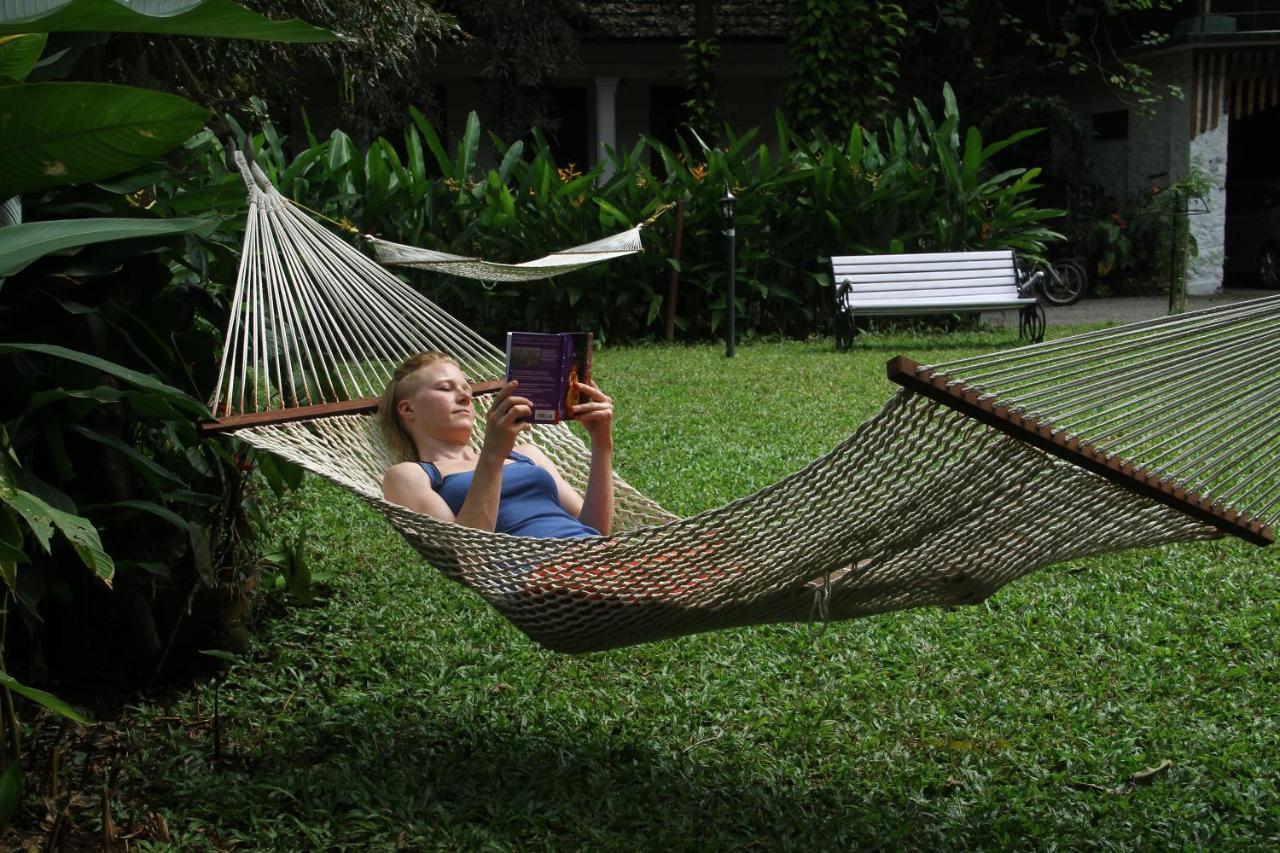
[137,715,962,849]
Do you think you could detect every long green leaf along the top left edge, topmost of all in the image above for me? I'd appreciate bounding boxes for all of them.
[0,0,338,44]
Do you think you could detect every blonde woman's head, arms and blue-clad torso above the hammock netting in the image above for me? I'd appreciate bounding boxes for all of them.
[378,352,613,538]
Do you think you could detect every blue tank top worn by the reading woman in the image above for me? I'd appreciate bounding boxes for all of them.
[419,451,600,539]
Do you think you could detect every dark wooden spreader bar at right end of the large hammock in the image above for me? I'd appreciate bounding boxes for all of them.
[888,356,1275,546]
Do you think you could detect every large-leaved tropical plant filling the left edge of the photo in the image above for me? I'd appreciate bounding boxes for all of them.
[0,0,333,824]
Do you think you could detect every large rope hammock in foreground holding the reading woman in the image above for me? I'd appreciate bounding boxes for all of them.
[209,155,1280,652]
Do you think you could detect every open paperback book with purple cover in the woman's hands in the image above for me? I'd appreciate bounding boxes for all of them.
[507,332,591,424]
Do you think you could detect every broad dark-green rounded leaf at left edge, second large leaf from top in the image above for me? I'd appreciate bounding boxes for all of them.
[0,83,207,197]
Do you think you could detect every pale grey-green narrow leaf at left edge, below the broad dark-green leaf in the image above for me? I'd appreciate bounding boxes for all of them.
[0,213,212,278]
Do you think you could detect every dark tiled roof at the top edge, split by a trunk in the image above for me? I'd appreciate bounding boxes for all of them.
[581,0,791,41]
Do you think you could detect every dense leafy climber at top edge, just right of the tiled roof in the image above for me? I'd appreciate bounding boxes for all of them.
[787,0,908,137]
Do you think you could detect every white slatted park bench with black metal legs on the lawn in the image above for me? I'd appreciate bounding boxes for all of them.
[831,248,1044,350]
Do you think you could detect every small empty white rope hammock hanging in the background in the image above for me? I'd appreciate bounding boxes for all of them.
[366,225,644,282]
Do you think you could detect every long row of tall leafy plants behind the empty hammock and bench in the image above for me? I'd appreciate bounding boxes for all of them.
[172,83,1056,341]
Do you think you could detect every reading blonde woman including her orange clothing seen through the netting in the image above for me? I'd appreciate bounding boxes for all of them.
[378,352,723,603]
